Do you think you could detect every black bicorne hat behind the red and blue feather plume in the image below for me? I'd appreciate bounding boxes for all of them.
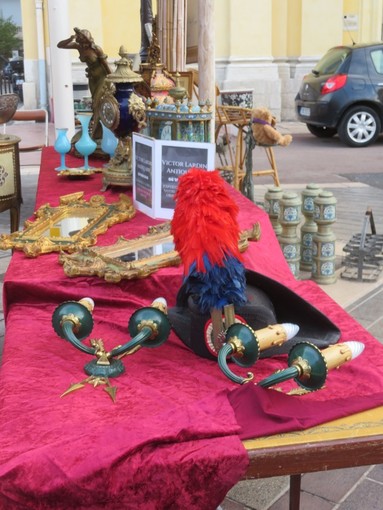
[168,270,340,359]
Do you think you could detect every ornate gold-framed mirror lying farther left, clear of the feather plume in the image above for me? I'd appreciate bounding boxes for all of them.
[0,192,136,257]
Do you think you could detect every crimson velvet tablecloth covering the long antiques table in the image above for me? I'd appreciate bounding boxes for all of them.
[0,148,383,510]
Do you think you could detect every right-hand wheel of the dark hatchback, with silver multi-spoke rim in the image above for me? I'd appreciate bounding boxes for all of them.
[338,106,381,147]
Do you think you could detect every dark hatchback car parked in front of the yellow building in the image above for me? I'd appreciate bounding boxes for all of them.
[295,43,383,147]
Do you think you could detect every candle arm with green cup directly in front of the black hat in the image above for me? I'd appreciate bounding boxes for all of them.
[218,322,299,384]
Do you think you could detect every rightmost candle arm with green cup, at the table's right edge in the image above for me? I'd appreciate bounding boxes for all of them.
[258,341,364,391]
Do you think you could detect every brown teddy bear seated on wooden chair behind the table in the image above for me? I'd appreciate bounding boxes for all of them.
[251,107,293,147]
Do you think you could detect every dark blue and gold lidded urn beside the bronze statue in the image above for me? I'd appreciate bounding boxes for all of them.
[99,46,146,190]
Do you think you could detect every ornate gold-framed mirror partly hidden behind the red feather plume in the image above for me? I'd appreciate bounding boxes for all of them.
[59,222,261,283]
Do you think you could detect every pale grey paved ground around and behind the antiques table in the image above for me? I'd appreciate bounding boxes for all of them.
[0,123,383,510]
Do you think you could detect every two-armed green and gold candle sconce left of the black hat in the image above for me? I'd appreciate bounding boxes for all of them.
[52,298,171,401]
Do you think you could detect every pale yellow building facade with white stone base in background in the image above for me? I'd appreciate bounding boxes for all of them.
[15,0,383,120]
